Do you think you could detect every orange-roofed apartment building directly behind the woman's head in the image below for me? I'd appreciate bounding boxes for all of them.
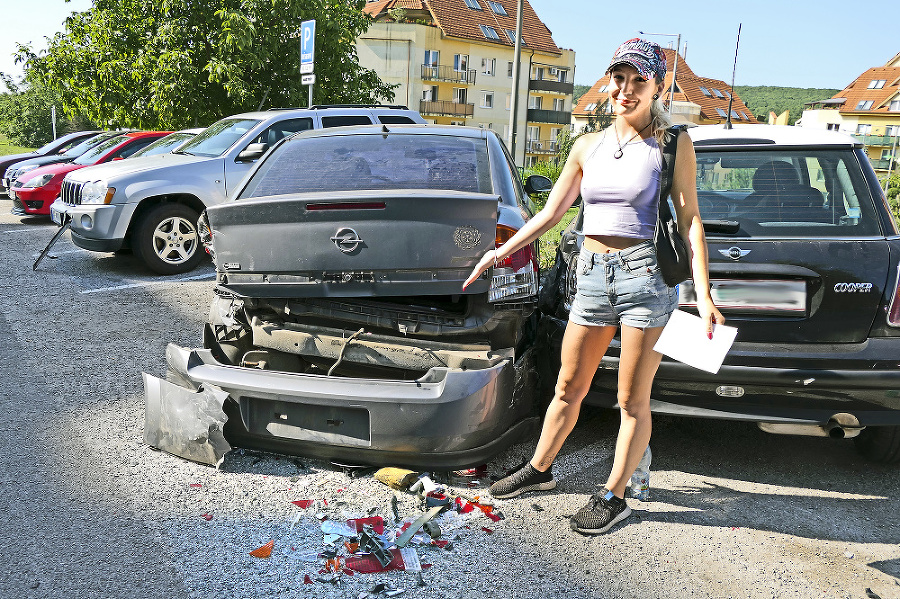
[572,48,758,131]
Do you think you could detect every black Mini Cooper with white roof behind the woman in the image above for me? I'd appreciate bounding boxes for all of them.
[540,125,900,462]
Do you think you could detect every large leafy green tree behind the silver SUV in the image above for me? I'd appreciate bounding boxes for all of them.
[19,0,394,129]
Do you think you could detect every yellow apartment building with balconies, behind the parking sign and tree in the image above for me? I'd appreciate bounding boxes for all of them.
[356,0,575,166]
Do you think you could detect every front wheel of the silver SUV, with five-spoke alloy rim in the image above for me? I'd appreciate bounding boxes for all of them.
[132,204,203,275]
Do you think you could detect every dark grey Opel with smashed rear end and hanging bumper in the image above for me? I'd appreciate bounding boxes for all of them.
[144,125,550,468]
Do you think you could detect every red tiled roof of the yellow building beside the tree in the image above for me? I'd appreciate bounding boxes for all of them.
[363,0,561,54]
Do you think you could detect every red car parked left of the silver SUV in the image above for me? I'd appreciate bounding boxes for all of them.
[10,131,171,216]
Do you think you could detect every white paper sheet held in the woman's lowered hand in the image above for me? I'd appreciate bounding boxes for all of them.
[653,310,737,374]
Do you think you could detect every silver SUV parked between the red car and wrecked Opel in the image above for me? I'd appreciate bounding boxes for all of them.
[51,106,425,274]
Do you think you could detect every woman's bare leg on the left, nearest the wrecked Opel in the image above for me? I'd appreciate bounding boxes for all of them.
[531,322,624,476]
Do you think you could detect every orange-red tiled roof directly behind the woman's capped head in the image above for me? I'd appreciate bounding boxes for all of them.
[573,48,757,123]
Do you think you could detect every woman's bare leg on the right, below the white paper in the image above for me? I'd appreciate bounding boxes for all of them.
[606,325,663,497]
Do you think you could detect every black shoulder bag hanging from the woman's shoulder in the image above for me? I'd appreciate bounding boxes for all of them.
[653,125,691,287]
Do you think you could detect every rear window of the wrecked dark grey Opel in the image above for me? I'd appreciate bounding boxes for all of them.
[240,134,492,198]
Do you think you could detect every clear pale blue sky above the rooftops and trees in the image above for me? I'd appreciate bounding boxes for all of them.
[0,0,900,89]
